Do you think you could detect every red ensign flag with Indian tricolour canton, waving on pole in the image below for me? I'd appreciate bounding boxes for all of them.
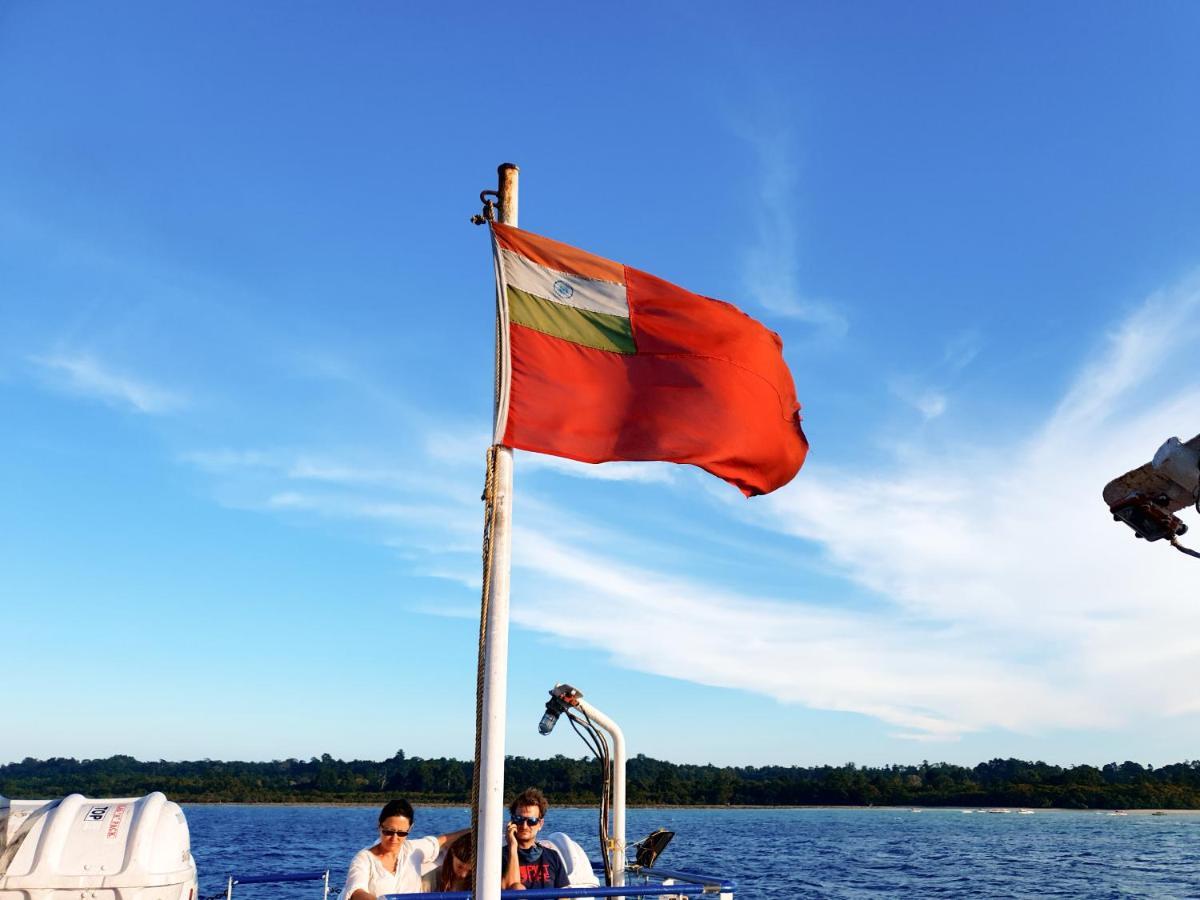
[492,223,809,497]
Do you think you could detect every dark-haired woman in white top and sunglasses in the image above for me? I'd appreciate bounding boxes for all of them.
[342,799,470,900]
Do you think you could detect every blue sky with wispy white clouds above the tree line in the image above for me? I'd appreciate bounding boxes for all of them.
[0,2,1200,764]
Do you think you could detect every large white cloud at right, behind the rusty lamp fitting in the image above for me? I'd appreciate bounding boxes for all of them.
[748,274,1200,728]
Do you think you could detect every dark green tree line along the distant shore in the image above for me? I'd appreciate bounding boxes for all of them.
[0,750,1200,809]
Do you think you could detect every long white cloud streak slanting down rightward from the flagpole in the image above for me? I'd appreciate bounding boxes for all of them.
[512,529,1103,738]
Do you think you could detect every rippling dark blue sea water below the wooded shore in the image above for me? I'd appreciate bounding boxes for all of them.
[185,805,1200,900]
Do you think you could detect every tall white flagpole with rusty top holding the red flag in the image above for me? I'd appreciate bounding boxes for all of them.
[475,163,518,900]
